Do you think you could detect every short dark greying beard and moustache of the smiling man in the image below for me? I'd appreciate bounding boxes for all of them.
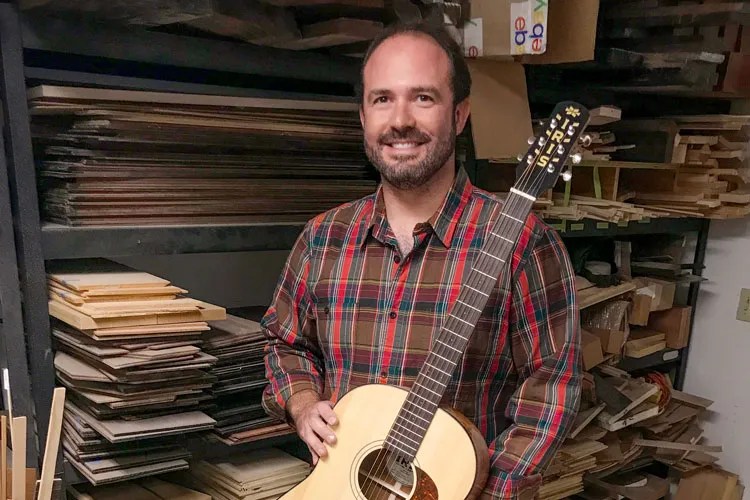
[365,117,456,190]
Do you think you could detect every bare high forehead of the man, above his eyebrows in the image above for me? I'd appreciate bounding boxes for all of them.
[363,33,450,89]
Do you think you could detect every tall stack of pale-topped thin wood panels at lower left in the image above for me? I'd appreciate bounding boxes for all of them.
[47,260,220,484]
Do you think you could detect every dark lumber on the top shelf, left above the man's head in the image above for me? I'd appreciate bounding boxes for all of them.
[19,0,412,54]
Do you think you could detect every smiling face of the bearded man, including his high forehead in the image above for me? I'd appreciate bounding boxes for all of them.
[360,35,468,189]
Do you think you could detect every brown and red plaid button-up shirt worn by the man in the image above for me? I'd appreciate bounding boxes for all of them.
[262,169,581,499]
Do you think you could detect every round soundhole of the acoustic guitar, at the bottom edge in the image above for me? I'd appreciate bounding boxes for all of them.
[357,449,415,500]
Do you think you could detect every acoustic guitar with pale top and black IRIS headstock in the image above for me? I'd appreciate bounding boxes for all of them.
[281,101,589,500]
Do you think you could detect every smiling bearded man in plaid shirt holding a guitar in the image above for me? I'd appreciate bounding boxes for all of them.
[263,20,581,500]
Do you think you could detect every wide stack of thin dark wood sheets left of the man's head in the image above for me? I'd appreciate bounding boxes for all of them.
[28,86,376,225]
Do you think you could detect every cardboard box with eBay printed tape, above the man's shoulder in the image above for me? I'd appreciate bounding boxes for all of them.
[462,0,599,64]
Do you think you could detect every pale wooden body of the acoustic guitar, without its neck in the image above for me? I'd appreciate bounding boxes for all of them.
[281,384,489,500]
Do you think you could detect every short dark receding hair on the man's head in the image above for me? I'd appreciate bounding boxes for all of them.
[356,22,471,106]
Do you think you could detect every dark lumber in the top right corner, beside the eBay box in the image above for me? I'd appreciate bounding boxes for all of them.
[565,0,750,95]
